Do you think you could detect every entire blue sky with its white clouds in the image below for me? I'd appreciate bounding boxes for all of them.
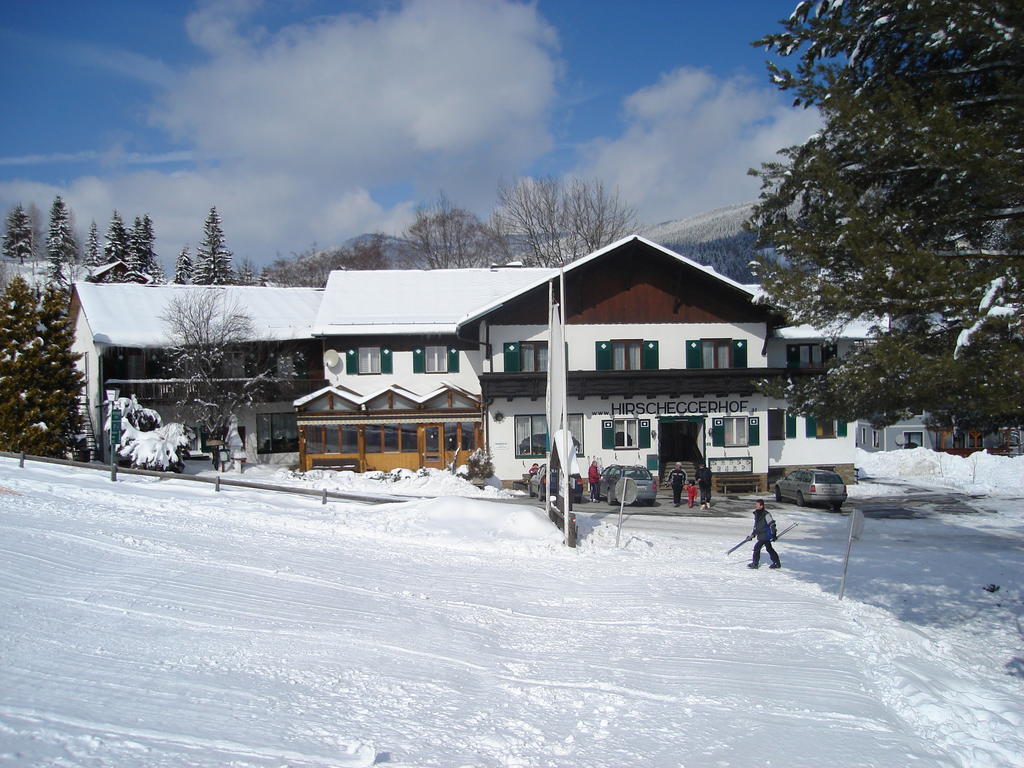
[0,0,818,264]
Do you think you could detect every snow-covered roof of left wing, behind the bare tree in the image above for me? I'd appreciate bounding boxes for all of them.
[75,282,324,347]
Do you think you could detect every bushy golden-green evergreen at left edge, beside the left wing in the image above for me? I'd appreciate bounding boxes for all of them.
[0,276,82,456]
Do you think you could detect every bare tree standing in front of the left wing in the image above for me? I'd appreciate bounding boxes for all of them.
[161,287,269,439]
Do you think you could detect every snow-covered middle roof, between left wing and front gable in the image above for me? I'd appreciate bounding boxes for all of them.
[313,267,558,336]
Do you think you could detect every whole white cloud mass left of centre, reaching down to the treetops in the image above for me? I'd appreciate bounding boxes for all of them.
[0,0,559,264]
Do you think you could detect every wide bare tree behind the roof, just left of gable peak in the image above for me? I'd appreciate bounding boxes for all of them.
[493,176,636,266]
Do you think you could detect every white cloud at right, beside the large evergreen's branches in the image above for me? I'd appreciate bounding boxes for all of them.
[577,69,821,223]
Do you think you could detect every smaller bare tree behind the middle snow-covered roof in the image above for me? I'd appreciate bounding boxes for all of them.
[402,193,499,269]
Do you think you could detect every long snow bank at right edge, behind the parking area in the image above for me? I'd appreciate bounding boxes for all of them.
[856,447,1024,497]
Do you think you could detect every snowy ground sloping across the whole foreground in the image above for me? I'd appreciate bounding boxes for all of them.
[0,451,1024,768]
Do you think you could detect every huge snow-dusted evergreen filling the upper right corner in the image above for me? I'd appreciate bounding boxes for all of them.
[752,0,1024,428]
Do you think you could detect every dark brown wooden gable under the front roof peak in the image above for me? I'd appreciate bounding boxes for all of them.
[479,240,769,325]
